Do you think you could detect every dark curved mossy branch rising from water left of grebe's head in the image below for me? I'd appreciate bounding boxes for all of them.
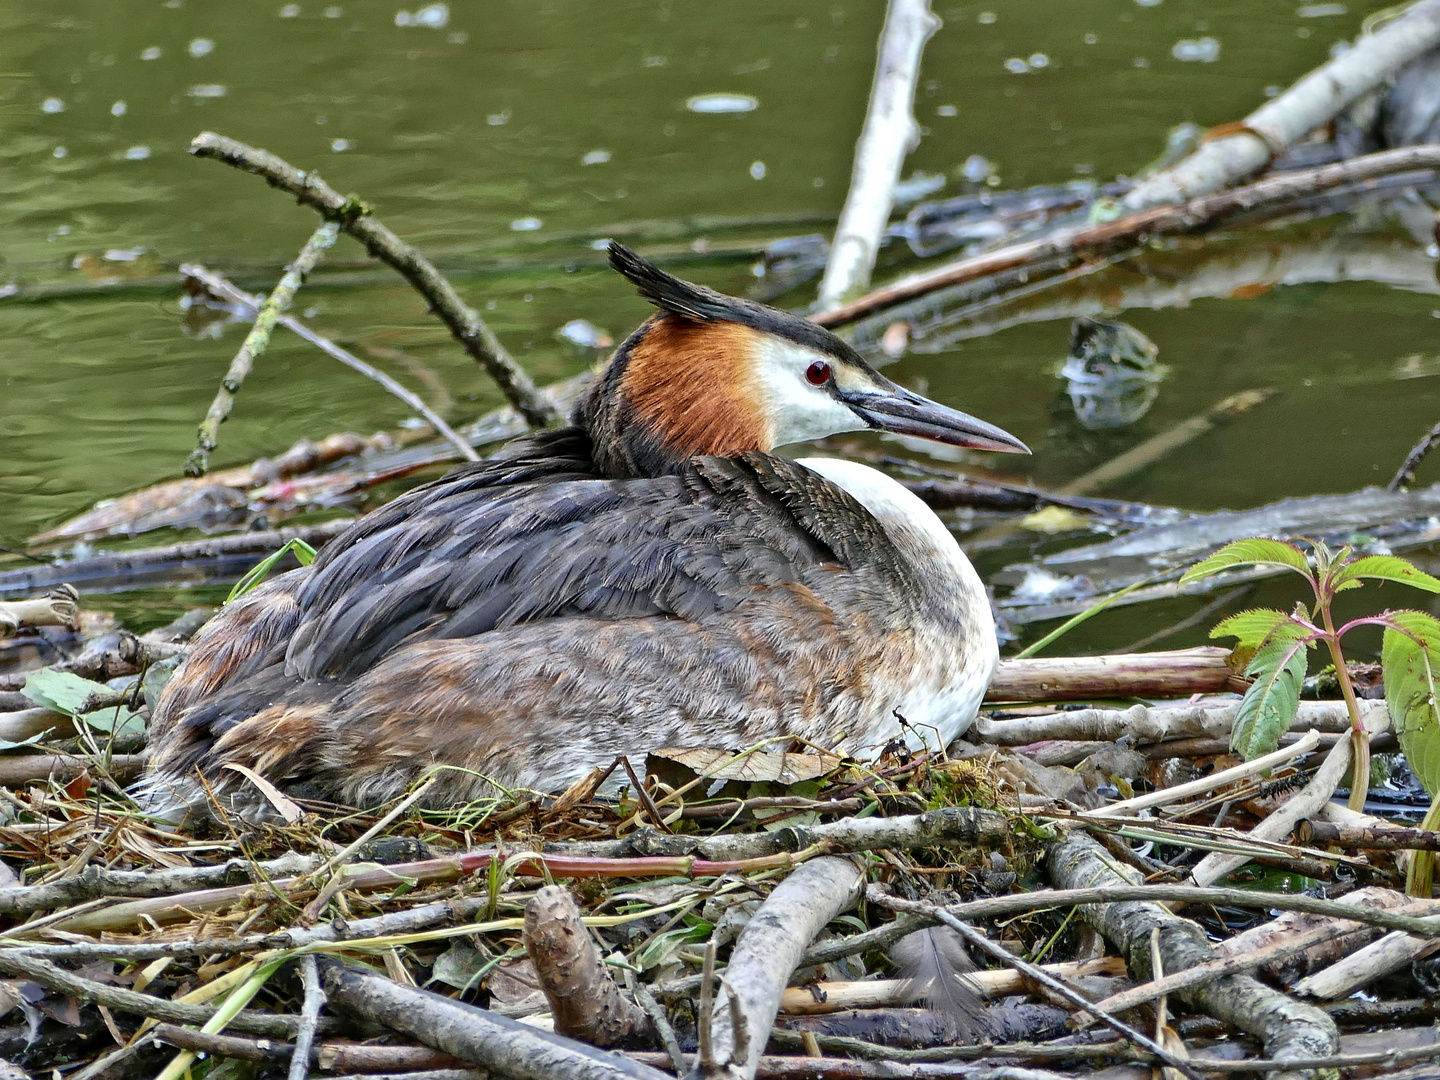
[190,131,560,428]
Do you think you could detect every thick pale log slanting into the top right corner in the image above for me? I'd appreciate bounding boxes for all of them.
[1123,0,1440,212]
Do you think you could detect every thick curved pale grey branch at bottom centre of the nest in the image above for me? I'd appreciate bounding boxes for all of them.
[690,855,865,1080]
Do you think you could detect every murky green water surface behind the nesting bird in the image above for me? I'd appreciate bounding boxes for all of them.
[0,0,1440,647]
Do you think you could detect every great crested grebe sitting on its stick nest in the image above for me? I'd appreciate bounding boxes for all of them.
[145,243,1027,812]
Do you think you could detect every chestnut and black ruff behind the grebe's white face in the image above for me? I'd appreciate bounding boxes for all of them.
[575,314,772,477]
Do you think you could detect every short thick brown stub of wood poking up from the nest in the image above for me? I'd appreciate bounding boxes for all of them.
[524,886,654,1047]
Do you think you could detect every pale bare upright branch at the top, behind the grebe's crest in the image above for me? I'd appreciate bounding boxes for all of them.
[819,0,940,308]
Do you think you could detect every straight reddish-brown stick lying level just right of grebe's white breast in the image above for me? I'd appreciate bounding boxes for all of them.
[985,645,1250,701]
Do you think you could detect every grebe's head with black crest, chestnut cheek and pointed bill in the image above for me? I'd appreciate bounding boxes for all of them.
[575,249,1030,475]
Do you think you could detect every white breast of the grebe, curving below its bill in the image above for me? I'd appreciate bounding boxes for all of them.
[799,458,999,749]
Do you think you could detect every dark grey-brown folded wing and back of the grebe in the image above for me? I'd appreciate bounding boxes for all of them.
[153,429,923,812]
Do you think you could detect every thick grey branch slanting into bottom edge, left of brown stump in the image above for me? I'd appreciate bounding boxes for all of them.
[320,958,671,1080]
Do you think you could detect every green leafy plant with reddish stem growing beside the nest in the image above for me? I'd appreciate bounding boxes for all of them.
[1181,540,1440,864]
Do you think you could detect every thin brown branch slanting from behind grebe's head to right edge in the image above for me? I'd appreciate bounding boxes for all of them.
[814,146,1440,327]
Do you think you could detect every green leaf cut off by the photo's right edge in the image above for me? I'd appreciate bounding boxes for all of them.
[1380,611,1440,798]
